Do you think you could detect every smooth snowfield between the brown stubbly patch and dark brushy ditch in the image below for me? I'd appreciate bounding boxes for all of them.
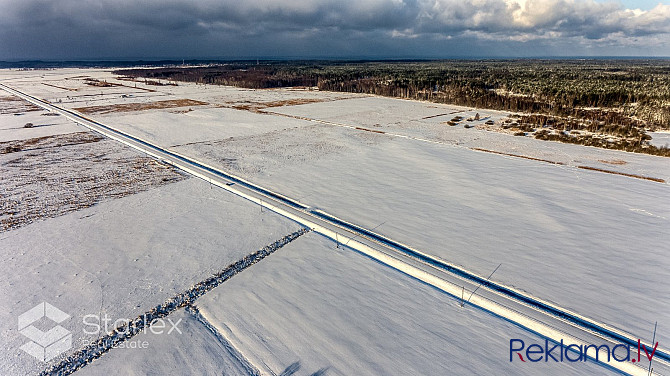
[0,178,299,375]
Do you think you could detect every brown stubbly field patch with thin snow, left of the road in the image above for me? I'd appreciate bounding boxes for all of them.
[0,132,187,232]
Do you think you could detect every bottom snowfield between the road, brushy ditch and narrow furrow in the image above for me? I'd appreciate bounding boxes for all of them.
[197,233,603,375]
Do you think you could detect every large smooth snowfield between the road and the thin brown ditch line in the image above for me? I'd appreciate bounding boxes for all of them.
[183,123,670,344]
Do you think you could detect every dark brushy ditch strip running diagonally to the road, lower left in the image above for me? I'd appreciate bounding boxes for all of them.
[40,228,310,376]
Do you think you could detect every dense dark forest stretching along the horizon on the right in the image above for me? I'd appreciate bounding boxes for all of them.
[117,60,670,129]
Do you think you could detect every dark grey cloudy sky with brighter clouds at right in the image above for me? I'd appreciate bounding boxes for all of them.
[0,0,670,60]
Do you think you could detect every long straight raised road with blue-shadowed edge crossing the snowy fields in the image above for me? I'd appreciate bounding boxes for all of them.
[0,84,670,375]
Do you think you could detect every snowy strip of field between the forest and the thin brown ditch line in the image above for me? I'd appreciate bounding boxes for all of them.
[269,97,670,181]
